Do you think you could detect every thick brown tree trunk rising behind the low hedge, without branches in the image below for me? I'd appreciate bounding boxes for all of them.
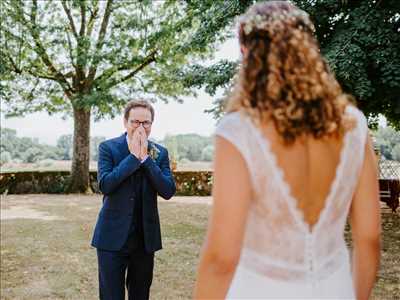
[67,107,92,193]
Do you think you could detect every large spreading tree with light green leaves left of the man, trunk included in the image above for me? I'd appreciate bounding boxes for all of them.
[0,0,248,192]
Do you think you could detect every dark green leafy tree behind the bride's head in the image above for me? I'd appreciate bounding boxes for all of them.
[181,0,400,129]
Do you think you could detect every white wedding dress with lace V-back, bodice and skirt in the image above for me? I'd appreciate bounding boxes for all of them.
[216,106,368,299]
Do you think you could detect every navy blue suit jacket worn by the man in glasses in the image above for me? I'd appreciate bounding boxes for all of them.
[92,133,176,253]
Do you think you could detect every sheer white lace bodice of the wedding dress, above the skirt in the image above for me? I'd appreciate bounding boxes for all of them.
[216,106,368,281]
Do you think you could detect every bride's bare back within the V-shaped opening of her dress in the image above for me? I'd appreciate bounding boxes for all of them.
[262,123,344,226]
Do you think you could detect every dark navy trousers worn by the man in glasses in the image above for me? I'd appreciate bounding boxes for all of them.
[97,237,154,300]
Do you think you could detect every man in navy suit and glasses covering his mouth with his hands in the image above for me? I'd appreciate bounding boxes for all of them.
[92,101,176,300]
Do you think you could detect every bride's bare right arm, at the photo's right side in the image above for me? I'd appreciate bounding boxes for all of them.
[351,137,381,300]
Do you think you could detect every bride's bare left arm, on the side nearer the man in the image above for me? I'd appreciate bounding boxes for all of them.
[194,136,251,299]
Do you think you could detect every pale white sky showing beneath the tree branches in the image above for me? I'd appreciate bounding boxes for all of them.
[0,39,239,145]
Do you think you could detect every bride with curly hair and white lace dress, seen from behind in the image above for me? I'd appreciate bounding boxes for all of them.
[194,1,380,299]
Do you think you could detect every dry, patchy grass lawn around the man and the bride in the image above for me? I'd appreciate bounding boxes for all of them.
[0,195,400,300]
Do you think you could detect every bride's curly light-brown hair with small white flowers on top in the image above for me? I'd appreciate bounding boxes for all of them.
[227,1,352,144]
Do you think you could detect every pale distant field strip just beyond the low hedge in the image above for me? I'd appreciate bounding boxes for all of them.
[1,160,212,172]
